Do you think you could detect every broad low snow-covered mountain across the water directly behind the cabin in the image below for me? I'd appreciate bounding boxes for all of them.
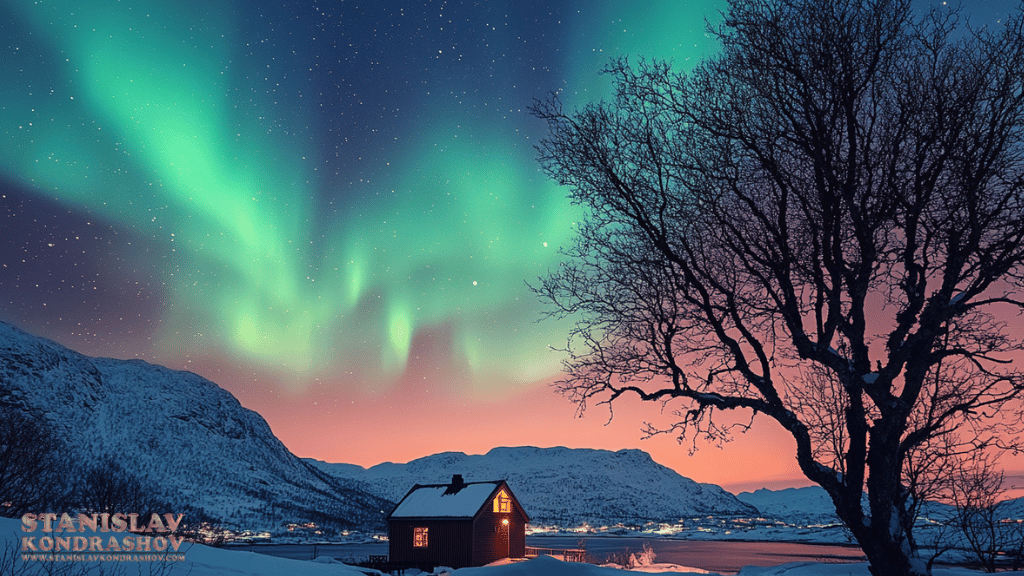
[309,447,757,527]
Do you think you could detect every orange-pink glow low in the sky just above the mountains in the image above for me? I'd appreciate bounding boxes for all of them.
[197,350,810,492]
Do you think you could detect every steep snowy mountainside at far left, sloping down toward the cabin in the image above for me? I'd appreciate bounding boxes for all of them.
[0,322,392,530]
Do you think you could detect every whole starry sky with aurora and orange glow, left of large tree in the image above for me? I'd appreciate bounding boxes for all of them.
[0,0,1015,494]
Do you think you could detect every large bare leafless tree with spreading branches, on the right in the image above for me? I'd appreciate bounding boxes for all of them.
[534,0,1024,576]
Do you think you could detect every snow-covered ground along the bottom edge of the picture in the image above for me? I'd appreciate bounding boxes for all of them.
[0,518,1024,576]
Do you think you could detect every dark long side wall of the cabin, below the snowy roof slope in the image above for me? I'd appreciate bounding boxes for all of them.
[388,519,474,568]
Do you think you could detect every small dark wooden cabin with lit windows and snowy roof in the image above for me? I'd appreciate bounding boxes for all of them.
[387,475,529,569]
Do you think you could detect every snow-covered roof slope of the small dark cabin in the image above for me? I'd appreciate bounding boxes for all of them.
[390,479,508,518]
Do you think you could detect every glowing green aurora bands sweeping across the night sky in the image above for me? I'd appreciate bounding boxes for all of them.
[0,0,722,390]
